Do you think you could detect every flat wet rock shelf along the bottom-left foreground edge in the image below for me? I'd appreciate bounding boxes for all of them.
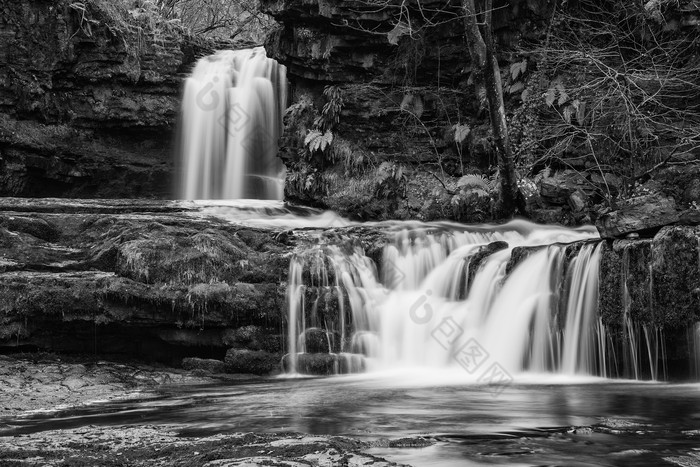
[0,424,403,467]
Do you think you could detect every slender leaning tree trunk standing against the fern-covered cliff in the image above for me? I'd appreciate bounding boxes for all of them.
[462,0,525,216]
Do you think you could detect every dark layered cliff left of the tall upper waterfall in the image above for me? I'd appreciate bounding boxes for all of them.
[0,0,205,197]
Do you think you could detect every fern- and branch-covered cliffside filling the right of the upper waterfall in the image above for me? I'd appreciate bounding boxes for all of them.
[262,0,700,229]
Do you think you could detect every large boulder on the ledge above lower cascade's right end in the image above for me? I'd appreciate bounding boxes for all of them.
[596,193,680,238]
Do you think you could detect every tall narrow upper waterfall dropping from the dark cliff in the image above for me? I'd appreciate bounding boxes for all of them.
[179,47,287,199]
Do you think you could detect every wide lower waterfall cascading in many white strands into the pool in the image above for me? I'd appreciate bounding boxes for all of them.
[286,221,628,380]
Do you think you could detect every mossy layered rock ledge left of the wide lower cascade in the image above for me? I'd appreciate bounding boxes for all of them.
[0,198,294,364]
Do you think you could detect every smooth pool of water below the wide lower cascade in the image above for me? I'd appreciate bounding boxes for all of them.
[0,373,700,466]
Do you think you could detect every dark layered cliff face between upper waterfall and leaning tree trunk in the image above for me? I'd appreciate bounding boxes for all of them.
[262,0,549,222]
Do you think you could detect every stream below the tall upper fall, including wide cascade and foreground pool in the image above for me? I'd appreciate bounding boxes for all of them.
[0,201,700,466]
